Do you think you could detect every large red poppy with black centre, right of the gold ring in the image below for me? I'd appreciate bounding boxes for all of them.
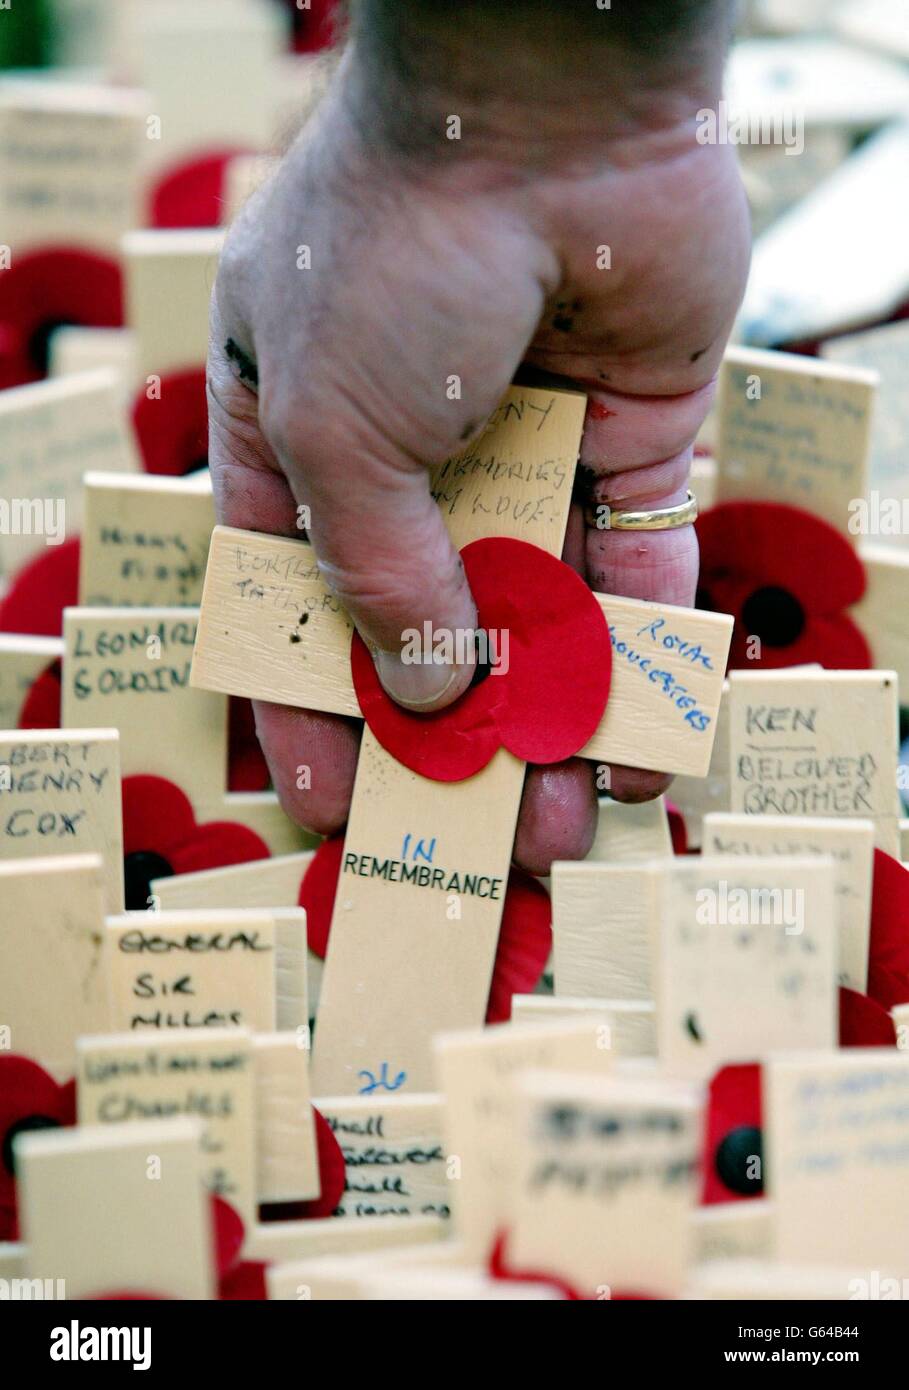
[696,502,871,670]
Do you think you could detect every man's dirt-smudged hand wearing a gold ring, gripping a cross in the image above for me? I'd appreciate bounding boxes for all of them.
[208,0,748,873]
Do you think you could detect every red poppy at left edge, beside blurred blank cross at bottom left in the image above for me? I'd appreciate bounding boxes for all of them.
[0,1052,76,1240]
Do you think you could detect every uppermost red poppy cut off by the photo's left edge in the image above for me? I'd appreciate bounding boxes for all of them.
[0,246,124,391]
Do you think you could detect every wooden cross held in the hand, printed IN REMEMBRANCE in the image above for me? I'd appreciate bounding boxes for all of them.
[192,388,731,1094]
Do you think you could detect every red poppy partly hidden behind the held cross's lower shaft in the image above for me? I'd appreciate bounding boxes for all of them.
[297,835,552,1023]
